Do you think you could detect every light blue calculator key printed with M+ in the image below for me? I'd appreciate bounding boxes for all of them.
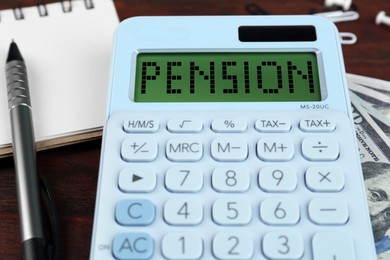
[257,137,294,161]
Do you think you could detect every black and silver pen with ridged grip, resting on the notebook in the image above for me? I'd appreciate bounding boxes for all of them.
[5,41,48,260]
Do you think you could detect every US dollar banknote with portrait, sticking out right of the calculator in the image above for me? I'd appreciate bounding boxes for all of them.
[349,90,390,259]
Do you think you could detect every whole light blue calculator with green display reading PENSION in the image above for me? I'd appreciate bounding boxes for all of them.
[90,15,376,260]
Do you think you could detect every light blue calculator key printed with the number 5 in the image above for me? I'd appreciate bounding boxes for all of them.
[212,199,252,225]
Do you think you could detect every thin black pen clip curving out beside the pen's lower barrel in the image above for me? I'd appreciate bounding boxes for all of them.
[40,178,60,260]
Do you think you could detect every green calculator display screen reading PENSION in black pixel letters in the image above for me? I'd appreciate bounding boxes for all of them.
[134,52,321,102]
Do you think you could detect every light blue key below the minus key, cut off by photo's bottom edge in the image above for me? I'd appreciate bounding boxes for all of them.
[312,232,356,260]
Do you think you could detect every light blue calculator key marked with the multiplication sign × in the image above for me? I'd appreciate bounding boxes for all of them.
[305,166,345,192]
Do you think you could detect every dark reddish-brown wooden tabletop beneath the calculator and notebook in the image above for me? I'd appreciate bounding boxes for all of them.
[0,0,390,260]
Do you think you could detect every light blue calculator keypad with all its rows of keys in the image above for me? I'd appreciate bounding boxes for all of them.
[91,111,374,260]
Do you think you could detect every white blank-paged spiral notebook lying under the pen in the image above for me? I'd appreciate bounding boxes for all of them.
[0,0,119,157]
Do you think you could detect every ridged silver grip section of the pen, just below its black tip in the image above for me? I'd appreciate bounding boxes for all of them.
[6,60,31,109]
